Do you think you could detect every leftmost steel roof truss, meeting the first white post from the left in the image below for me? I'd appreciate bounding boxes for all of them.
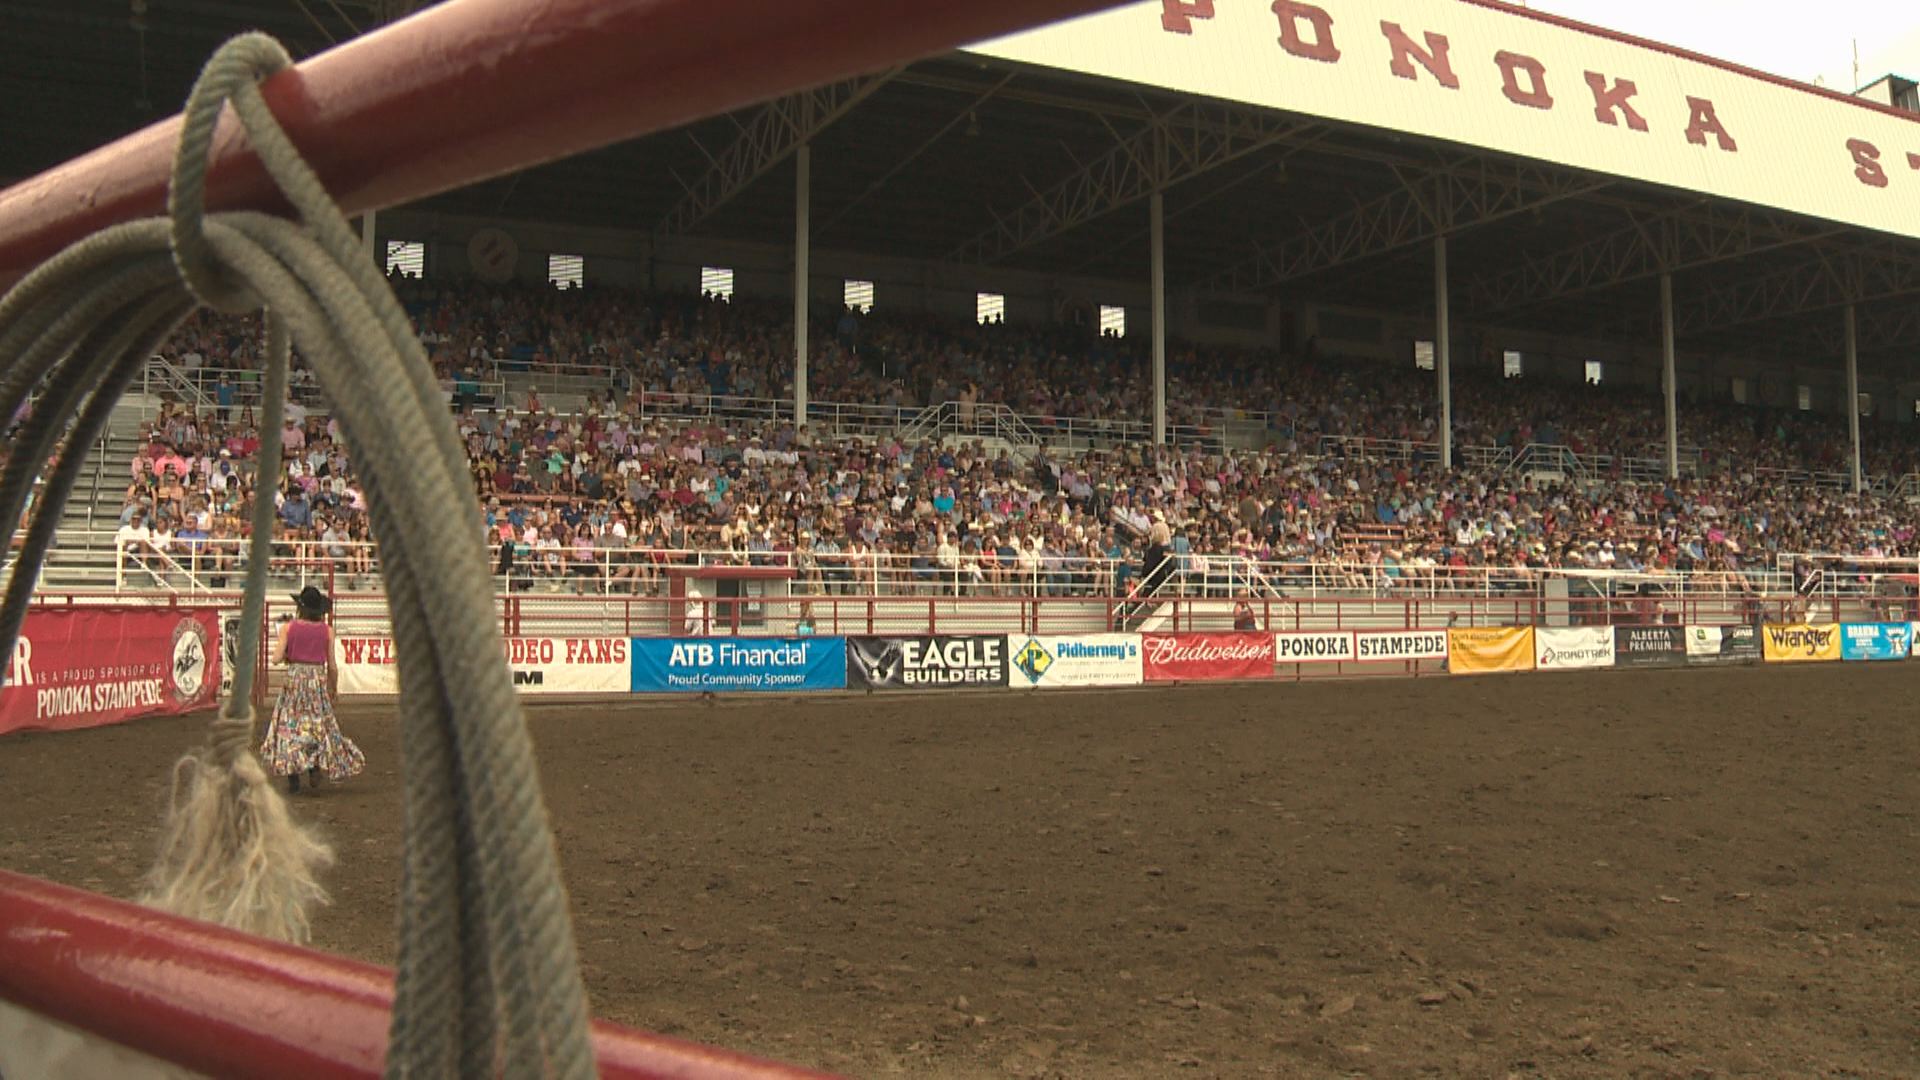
[655,67,900,236]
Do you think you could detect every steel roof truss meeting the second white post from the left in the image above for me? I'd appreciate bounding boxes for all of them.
[947,102,1315,265]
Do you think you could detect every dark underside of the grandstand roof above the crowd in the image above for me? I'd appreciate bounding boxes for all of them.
[11,0,1920,377]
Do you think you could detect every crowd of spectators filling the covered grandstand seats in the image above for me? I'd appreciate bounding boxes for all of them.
[121,282,1920,592]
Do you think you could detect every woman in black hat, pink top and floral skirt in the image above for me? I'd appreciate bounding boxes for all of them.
[259,584,367,794]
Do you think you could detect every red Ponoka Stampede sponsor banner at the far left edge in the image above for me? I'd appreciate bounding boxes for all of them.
[0,607,221,734]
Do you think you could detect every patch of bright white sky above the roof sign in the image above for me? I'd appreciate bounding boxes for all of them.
[1524,0,1920,92]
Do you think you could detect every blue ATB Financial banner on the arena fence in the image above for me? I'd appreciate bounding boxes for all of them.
[634,638,847,694]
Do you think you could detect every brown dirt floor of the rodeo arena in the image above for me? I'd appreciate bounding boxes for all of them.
[0,663,1920,1076]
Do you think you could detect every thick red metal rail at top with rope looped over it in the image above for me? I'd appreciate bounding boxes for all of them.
[0,0,1117,288]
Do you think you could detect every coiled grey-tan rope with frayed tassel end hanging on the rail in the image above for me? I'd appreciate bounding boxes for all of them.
[0,35,595,1078]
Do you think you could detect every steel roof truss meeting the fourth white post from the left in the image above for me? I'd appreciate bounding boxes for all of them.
[1465,202,1843,319]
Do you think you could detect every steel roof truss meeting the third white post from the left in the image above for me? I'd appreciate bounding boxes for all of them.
[1200,158,1611,292]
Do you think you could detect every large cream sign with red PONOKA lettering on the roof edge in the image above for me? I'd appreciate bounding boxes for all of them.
[973,0,1920,236]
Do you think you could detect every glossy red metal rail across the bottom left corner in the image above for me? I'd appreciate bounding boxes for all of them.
[0,871,837,1080]
